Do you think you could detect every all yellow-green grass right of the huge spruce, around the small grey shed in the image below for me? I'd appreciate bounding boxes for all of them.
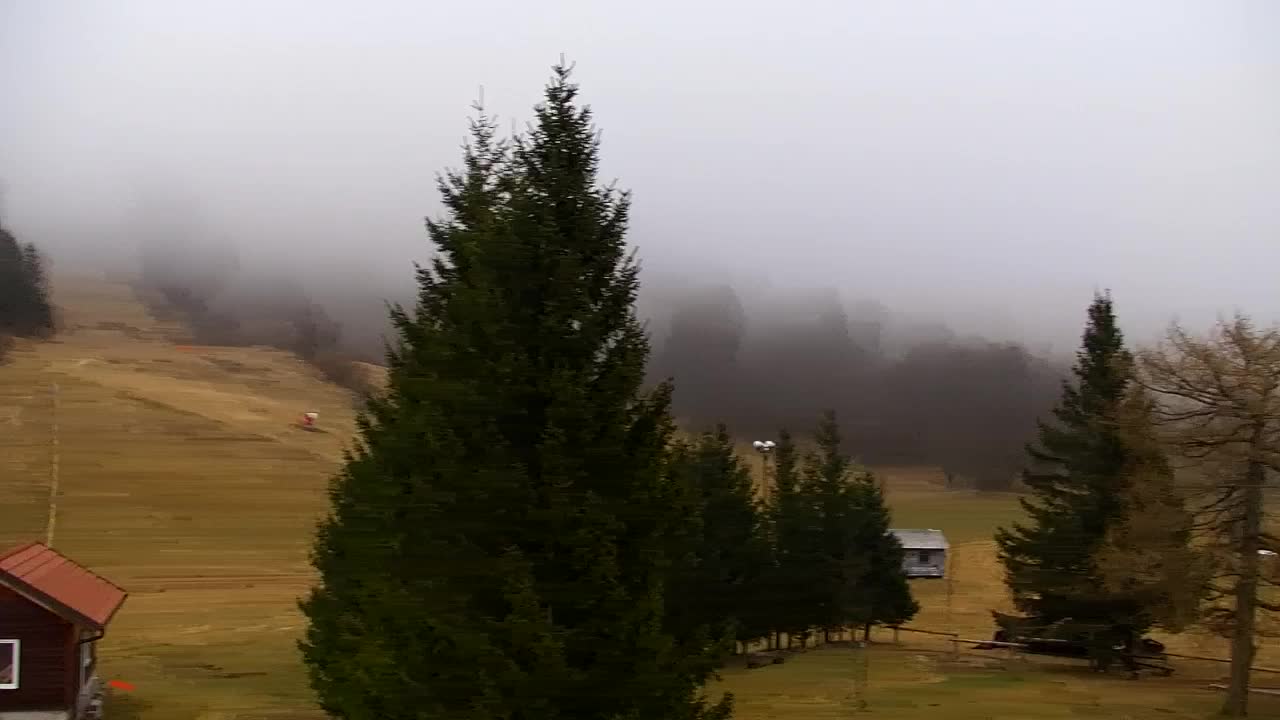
[716,468,1280,720]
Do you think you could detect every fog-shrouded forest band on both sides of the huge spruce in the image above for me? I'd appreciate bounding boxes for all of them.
[132,233,1064,489]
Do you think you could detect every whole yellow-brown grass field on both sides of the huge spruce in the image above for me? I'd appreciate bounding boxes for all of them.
[0,278,1280,720]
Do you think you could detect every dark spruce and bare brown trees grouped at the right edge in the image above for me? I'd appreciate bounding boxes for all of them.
[996,289,1280,716]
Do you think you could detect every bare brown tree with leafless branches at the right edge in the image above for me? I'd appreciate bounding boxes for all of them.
[1140,315,1280,717]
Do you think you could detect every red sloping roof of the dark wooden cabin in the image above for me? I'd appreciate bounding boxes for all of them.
[0,542,128,629]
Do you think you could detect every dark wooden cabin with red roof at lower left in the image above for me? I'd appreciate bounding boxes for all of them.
[0,542,125,720]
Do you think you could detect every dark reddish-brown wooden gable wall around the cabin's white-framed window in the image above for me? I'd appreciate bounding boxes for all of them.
[0,587,74,712]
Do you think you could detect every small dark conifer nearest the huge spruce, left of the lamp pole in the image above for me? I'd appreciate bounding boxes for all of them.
[667,425,771,652]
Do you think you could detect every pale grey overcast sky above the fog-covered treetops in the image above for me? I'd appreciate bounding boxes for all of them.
[0,0,1280,345]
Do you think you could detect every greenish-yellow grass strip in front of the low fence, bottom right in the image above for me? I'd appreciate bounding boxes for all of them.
[714,642,1280,720]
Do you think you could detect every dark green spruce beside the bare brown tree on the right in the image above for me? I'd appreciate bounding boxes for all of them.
[996,295,1167,641]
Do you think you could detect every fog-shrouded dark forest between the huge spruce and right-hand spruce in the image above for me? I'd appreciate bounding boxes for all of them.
[649,280,1062,489]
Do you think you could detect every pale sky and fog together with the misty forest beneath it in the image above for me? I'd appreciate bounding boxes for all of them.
[0,0,1280,478]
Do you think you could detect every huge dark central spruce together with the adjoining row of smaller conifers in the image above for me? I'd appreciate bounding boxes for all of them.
[301,67,916,720]
